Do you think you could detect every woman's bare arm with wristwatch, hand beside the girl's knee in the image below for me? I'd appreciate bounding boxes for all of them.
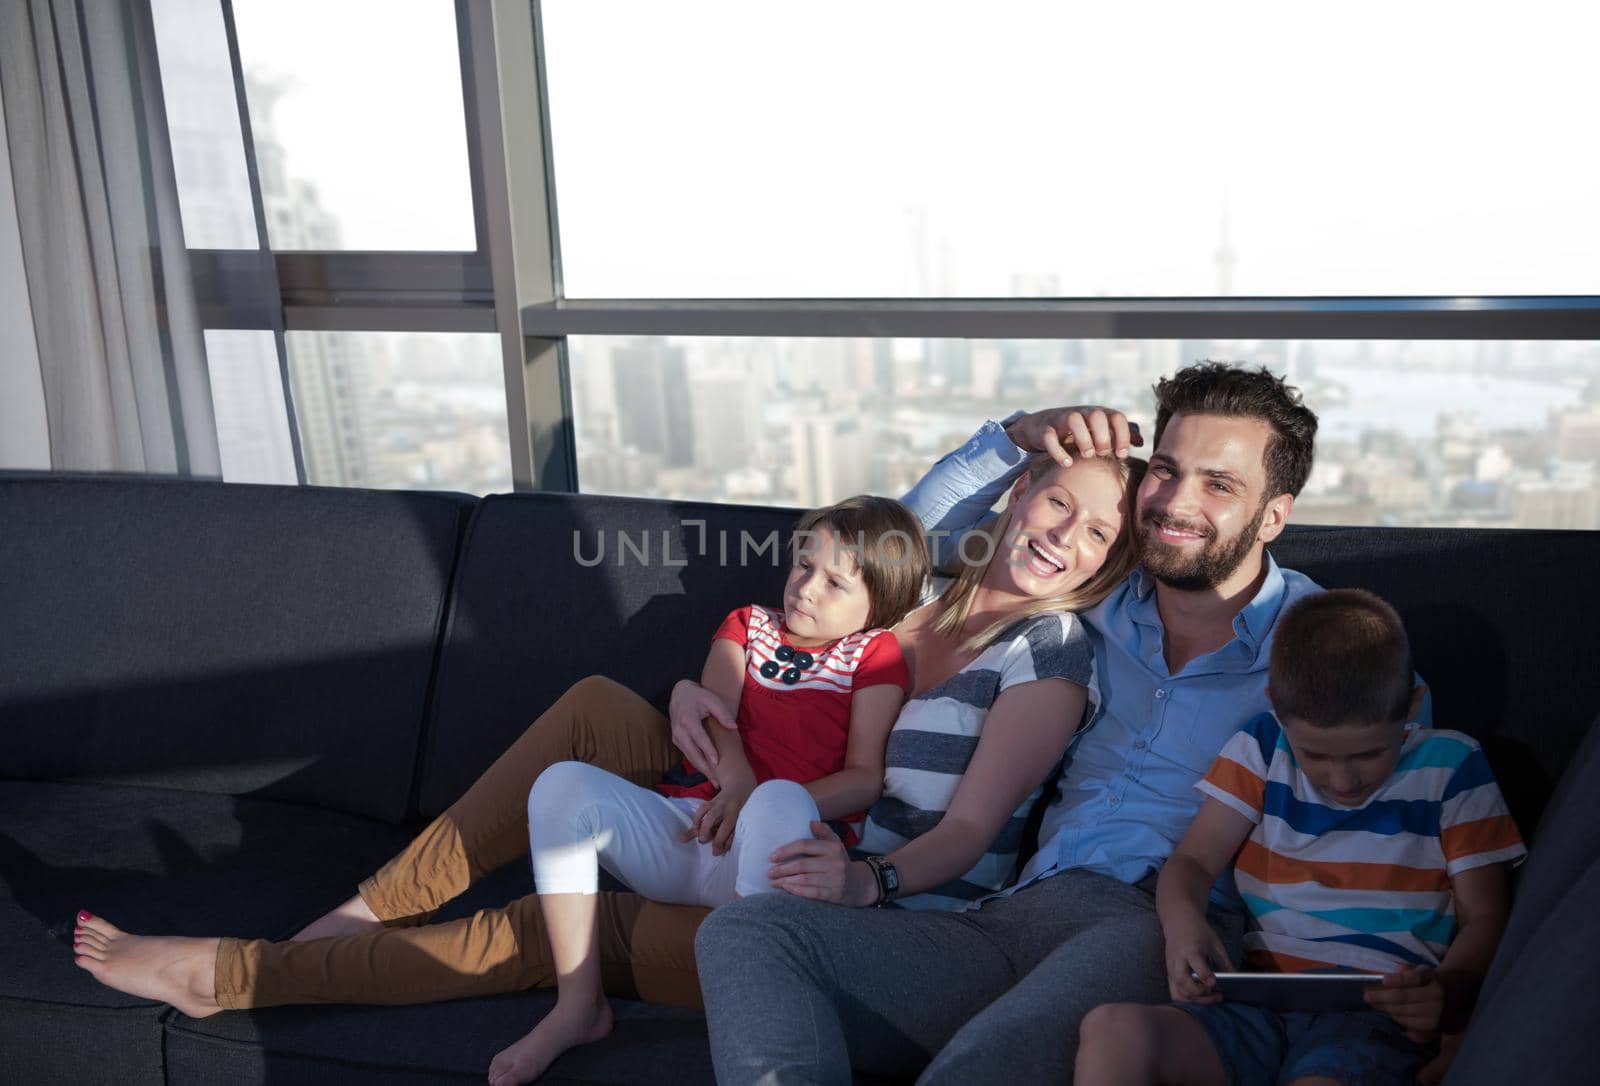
[768,678,1086,905]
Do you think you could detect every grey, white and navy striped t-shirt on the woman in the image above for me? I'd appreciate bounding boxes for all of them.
[861,613,1098,910]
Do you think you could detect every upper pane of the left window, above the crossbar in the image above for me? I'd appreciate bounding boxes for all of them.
[234,0,477,250]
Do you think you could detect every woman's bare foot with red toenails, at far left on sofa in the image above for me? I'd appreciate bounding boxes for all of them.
[72,913,221,1019]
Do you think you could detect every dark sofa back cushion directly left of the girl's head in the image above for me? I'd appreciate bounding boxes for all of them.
[419,494,798,814]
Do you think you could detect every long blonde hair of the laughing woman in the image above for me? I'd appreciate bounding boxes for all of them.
[933,453,1147,653]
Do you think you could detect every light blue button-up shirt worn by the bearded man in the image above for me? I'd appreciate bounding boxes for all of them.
[906,416,1427,886]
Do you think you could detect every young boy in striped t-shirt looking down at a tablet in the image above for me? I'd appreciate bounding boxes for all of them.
[1075,590,1526,1086]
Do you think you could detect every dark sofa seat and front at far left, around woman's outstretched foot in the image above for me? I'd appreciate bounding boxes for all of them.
[0,781,419,1083]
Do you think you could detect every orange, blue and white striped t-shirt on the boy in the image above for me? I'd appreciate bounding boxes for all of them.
[1195,713,1528,972]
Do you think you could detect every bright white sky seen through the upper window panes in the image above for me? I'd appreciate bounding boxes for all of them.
[209,0,1600,297]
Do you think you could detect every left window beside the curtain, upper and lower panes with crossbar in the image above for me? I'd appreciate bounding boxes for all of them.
[152,0,512,493]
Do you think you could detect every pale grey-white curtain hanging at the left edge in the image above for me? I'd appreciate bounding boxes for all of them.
[0,0,221,477]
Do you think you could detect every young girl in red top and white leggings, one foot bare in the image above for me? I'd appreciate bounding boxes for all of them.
[490,496,928,1086]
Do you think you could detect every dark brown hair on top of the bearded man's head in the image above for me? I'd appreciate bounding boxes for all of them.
[1155,361,1317,497]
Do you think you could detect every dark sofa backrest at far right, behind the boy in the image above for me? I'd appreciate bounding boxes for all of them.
[1272,526,1600,835]
